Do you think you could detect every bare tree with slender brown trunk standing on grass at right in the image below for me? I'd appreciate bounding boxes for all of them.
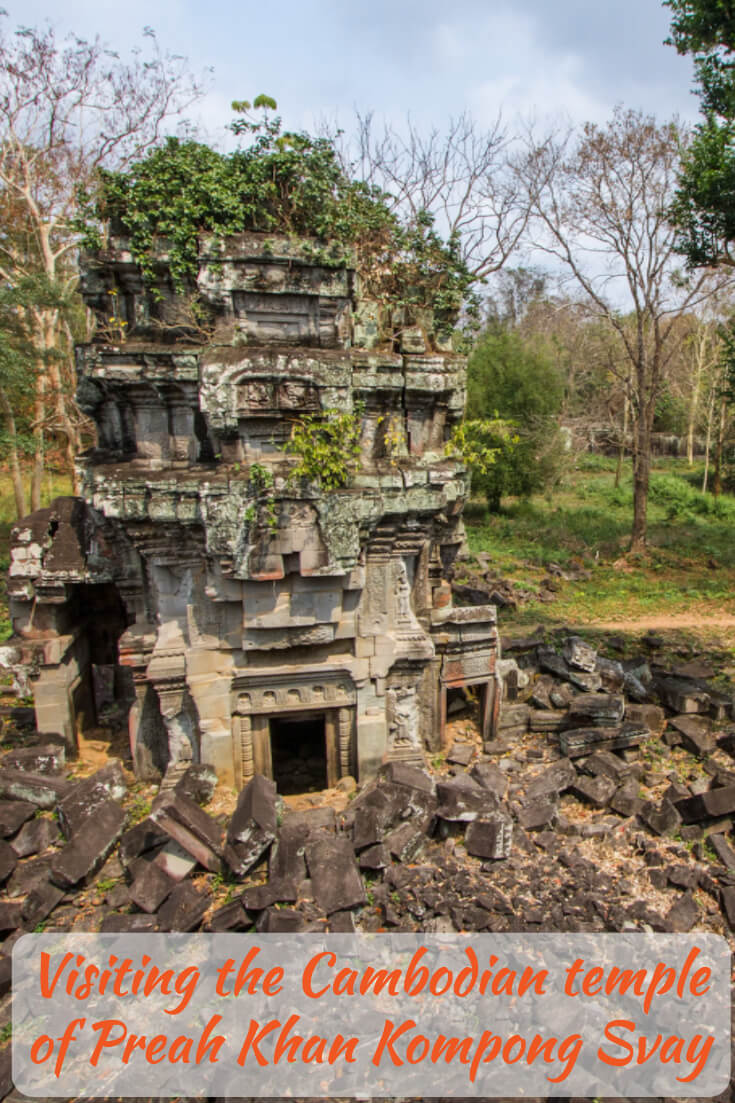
[521,108,716,552]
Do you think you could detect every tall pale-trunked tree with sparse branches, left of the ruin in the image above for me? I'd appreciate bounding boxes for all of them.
[0,17,201,510]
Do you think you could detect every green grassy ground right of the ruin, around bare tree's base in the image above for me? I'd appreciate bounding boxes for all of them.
[465,456,735,628]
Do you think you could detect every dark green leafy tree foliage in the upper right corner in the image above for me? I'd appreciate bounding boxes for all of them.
[664,0,735,267]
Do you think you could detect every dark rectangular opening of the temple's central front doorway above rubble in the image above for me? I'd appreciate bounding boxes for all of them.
[270,713,327,796]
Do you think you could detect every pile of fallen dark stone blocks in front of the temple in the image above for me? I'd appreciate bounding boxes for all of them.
[0,636,735,1088]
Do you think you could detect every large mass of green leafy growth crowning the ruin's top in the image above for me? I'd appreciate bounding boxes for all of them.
[78,96,477,336]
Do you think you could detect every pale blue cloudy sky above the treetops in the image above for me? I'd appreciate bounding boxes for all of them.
[3,0,697,143]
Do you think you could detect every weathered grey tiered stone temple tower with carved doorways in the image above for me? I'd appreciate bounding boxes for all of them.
[9,234,499,792]
